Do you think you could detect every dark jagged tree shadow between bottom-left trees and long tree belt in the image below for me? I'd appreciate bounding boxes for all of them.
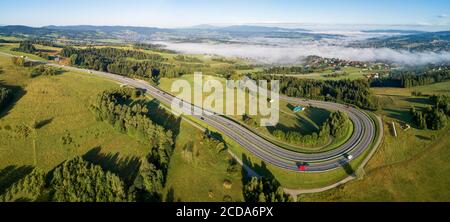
[83,147,141,184]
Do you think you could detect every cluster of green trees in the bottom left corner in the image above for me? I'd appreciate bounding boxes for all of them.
[0,157,132,202]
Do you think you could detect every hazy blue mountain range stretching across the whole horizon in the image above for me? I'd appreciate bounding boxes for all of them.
[0,25,450,51]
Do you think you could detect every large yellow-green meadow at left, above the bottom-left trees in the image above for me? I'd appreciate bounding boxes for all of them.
[0,56,149,170]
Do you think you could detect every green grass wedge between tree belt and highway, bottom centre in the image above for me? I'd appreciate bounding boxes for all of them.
[165,121,243,202]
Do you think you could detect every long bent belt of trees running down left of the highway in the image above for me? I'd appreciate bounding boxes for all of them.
[92,88,174,201]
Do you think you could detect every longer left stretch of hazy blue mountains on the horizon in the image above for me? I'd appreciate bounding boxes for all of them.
[0,25,338,41]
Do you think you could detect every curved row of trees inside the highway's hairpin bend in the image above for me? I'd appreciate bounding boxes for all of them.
[272,111,351,145]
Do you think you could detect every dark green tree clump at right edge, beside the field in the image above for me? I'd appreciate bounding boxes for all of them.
[410,95,450,130]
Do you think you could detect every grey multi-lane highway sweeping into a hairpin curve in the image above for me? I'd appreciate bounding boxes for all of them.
[1,53,376,172]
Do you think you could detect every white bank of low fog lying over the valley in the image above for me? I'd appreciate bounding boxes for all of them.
[158,42,450,65]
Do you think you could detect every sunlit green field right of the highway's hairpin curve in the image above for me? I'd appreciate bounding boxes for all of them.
[300,82,450,201]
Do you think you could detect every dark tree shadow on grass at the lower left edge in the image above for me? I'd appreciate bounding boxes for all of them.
[0,166,34,195]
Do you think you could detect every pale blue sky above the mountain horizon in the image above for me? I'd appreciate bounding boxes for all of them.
[0,0,450,27]
